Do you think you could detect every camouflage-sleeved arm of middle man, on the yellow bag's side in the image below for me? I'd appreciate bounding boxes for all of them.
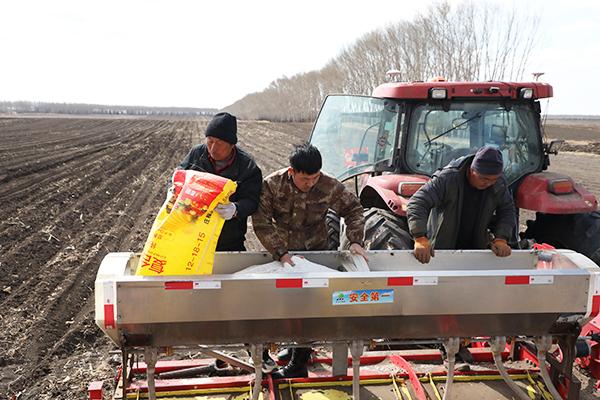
[252,181,288,260]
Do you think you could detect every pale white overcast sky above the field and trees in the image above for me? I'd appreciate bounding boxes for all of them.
[0,0,600,115]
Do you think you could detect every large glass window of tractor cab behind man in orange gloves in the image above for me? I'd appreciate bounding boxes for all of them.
[405,102,543,183]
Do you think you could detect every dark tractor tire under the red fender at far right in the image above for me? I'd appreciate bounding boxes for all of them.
[525,211,600,265]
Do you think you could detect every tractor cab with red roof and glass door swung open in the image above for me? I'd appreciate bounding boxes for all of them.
[311,82,552,188]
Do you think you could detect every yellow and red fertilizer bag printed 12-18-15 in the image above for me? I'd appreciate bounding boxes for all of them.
[136,170,236,276]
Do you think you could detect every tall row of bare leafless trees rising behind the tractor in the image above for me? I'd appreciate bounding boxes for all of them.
[226,2,539,121]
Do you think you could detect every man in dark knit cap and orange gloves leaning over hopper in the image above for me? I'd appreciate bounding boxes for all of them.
[407,146,516,263]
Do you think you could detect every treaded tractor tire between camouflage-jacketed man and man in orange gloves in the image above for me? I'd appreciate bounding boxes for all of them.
[364,208,413,250]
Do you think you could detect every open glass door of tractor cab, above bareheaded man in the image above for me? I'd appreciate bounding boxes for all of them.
[310,96,398,180]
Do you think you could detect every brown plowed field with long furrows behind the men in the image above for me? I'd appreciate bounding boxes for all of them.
[0,118,600,399]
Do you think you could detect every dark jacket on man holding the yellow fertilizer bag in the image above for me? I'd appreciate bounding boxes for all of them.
[178,144,262,251]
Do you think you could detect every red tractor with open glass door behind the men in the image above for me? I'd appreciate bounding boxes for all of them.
[310,81,600,264]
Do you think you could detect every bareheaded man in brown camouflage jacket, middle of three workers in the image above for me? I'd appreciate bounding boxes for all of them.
[252,143,367,379]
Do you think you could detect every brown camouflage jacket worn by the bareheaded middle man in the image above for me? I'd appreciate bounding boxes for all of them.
[252,168,365,259]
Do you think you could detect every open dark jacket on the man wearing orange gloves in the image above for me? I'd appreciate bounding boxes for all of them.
[407,156,516,249]
